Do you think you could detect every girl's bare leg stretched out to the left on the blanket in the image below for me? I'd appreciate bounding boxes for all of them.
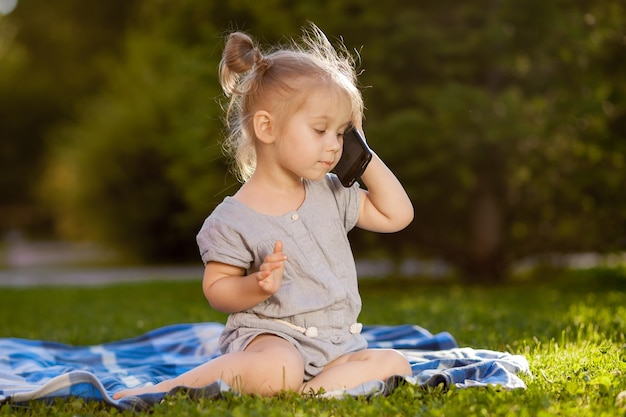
[113,334,304,399]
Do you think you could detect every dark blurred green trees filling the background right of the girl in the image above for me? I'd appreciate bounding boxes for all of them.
[346,0,626,282]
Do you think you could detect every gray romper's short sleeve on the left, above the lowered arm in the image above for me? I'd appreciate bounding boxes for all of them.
[196,203,253,269]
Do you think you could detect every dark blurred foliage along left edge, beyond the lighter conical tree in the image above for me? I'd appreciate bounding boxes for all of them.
[0,0,134,233]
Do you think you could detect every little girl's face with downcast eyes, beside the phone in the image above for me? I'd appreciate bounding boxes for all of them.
[276,88,352,181]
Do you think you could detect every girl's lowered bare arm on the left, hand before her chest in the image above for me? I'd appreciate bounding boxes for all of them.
[202,241,287,313]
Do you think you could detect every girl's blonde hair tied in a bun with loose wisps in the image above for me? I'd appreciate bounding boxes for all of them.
[219,23,363,182]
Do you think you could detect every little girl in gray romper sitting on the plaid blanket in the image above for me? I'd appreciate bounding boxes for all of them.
[115,25,413,399]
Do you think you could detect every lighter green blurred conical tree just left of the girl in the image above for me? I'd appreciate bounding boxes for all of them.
[45,2,234,261]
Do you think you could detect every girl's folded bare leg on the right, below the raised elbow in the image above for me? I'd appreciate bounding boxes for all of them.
[301,349,411,393]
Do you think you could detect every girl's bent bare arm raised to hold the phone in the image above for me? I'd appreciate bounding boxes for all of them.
[357,146,413,233]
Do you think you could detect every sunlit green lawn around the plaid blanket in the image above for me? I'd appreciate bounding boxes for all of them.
[0,269,626,417]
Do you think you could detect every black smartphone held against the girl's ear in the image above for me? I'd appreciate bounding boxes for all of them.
[333,126,372,187]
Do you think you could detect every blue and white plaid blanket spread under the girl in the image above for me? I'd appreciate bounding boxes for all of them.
[0,323,529,410]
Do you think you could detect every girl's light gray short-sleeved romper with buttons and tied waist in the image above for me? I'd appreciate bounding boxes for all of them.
[197,174,367,380]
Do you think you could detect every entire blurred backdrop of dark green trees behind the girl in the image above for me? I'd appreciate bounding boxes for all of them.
[0,0,626,283]
